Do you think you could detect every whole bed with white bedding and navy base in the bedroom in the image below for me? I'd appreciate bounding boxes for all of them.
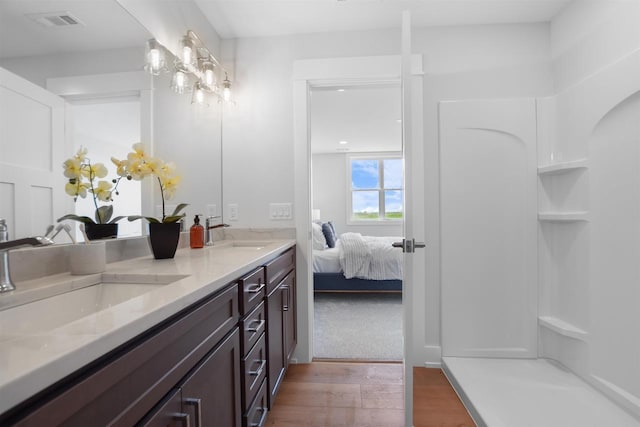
[313,233,402,292]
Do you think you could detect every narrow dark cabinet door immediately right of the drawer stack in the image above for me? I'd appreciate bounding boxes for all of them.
[267,286,285,409]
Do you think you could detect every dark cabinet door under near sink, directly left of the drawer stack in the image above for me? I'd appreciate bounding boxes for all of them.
[182,328,242,427]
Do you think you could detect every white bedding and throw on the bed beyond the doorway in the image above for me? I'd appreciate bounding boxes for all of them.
[313,233,402,280]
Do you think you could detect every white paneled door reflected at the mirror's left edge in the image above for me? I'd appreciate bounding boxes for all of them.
[0,68,66,240]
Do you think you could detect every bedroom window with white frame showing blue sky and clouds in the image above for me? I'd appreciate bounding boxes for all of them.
[349,156,403,222]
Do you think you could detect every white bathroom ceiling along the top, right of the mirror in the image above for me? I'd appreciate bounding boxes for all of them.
[195,0,571,38]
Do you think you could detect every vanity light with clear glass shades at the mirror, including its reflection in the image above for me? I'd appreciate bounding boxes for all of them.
[145,30,231,105]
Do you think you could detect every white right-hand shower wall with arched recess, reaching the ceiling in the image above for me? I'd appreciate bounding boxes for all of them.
[540,0,640,417]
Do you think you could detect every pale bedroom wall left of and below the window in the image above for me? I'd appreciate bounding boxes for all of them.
[311,154,402,236]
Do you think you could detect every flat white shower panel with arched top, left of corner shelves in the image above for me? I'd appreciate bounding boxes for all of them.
[440,99,538,358]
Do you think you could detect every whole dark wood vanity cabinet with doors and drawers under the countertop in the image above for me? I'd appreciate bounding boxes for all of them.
[0,249,296,427]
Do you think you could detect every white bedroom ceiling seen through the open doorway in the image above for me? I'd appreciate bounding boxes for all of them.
[310,84,402,153]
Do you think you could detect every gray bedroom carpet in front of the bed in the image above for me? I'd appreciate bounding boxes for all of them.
[313,293,402,360]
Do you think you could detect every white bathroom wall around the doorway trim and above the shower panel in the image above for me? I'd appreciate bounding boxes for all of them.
[222,23,553,363]
